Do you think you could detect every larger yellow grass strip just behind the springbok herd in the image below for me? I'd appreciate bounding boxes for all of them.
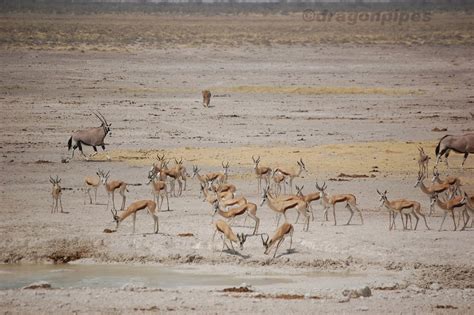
[95,141,474,184]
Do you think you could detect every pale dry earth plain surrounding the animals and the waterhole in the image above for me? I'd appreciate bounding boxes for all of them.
[0,11,474,314]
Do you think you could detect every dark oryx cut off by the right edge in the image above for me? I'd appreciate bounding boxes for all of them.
[435,133,474,168]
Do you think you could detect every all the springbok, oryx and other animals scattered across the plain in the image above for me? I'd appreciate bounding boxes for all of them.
[50,111,474,257]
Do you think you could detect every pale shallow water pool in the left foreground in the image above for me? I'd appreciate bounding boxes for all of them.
[0,264,291,289]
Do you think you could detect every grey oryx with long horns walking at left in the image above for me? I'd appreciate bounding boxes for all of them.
[67,111,112,159]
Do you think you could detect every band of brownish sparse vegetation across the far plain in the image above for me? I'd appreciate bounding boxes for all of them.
[0,10,474,50]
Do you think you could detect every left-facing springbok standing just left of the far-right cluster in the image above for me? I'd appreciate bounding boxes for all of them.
[377,189,430,231]
